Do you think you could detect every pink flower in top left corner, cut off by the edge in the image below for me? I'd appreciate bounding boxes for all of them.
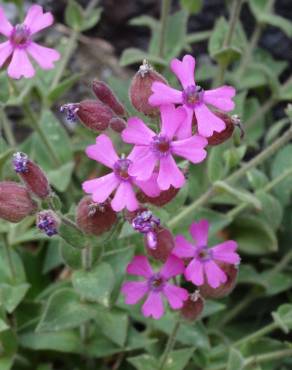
[0,5,60,79]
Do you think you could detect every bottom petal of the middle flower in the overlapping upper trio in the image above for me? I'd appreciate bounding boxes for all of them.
[157,155,185,190]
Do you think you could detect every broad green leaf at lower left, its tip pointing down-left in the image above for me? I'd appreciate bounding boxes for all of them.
[36,288,96,332]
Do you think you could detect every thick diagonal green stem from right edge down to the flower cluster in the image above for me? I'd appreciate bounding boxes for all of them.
[168,127,292,228]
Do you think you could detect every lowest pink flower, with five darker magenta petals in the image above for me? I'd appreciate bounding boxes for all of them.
[122,255,188,319]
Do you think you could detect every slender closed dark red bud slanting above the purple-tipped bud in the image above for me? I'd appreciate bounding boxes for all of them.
[92,80,126,116]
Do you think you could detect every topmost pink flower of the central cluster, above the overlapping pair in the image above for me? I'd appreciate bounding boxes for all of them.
[149,55,235,138]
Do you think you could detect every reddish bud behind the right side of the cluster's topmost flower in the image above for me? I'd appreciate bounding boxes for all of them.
[207,111,244,145]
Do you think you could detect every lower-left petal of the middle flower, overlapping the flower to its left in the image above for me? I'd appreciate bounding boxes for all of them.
[128,147,157,181]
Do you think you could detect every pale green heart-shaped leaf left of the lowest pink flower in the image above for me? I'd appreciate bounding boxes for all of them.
[72,262,115,307]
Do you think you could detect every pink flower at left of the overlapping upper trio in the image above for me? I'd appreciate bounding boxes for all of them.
[82,135,160,212]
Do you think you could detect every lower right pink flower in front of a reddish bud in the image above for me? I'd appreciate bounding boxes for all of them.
[172,220,240,288]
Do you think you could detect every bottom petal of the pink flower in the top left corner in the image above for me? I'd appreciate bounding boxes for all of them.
[8,49,34,79]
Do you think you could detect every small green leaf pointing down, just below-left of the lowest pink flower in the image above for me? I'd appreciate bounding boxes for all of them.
[95,308,129,347]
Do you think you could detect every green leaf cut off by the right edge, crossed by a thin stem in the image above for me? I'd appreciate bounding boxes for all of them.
[271,144,292,205]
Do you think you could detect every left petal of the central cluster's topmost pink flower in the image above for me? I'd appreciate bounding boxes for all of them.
[148,81,182,107]
